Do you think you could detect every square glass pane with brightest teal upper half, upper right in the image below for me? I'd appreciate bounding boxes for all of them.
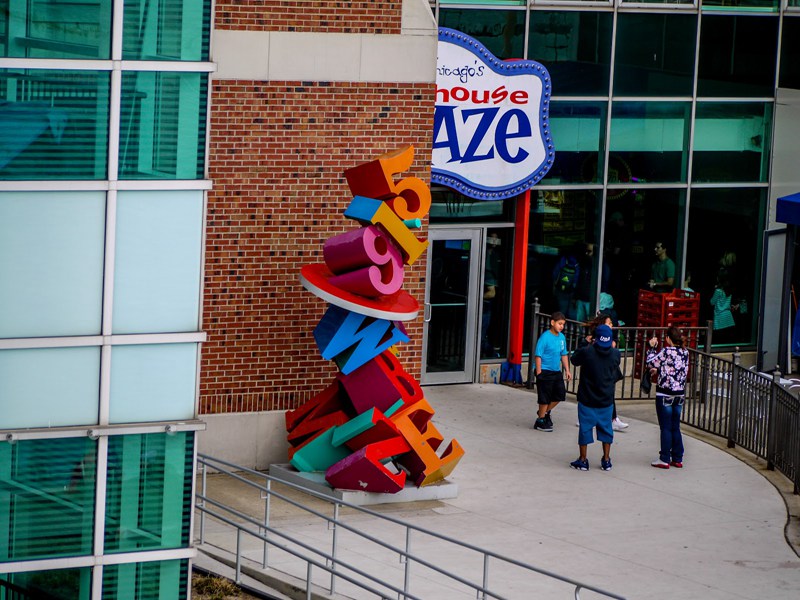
[692,102,772,183]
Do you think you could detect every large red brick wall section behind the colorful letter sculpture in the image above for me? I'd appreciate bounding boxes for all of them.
[200,82,435,413]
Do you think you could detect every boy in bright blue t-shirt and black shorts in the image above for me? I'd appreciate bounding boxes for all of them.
[533,312,572,431]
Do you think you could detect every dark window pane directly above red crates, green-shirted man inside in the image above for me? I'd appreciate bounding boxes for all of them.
[601,187,686,325]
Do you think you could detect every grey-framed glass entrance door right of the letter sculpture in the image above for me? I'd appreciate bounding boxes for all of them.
[422,229,482,384]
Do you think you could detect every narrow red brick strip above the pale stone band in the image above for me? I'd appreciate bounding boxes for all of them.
[214,0,403,34]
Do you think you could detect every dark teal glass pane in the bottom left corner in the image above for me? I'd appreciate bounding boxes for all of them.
[0,567,92,600]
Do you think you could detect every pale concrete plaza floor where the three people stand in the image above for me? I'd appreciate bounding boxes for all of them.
[197,384,800,600]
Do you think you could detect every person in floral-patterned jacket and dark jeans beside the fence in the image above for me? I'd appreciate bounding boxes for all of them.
[646,327,689,469]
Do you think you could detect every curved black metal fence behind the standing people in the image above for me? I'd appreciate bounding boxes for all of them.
[528,304,800,494]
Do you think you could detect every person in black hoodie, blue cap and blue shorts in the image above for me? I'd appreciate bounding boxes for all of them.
[570,325,622,471]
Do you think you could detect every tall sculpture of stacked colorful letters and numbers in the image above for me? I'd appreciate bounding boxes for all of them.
[286,146,464,493]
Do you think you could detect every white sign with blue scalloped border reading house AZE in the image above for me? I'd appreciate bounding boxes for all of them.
[431,27,555,200]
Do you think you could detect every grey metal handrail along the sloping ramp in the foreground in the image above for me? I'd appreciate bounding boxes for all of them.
[196,454,623,600]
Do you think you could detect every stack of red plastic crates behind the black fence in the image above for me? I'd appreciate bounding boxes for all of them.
[634,289,700,378]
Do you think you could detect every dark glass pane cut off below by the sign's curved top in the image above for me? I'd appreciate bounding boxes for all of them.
[439,8,525,60]
